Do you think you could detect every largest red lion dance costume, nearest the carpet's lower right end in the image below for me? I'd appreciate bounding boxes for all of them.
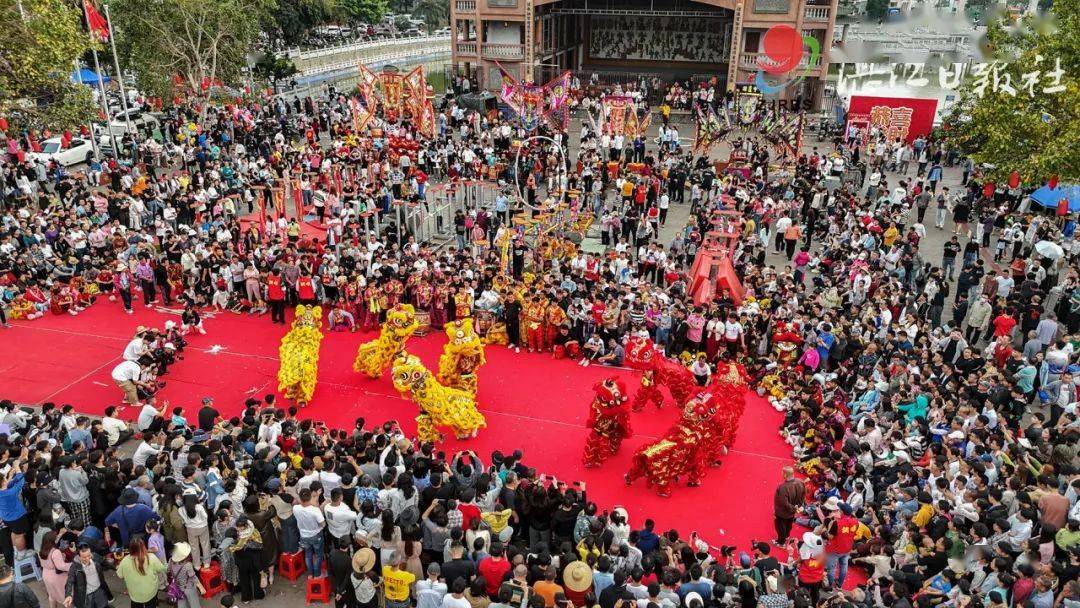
[625,364,746,497]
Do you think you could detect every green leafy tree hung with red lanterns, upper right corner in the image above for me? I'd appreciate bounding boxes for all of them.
[945,0,1080,184]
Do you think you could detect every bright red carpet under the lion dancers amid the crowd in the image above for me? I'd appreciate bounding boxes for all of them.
[0,301,791,549]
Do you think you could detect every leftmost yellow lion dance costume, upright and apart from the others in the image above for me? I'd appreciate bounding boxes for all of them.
[278,306,323,406]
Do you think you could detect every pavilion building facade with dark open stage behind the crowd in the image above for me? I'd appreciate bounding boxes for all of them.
[450,0,838,98]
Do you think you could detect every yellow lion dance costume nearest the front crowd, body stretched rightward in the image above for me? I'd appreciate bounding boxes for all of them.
[392,352,487,442]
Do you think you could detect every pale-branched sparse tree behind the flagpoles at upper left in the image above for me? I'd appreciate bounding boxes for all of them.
[111,0,276,109]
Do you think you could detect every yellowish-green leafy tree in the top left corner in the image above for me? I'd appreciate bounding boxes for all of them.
[0,0,94,132]
